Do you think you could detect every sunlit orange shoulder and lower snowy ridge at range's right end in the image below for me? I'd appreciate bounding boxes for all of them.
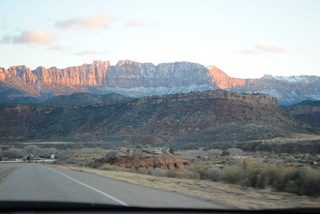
[208,66,320,105]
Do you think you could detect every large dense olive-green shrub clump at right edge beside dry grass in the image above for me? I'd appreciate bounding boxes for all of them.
[215,163,320,196]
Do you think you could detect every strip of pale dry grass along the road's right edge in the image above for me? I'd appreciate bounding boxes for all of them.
[53,166,320,209]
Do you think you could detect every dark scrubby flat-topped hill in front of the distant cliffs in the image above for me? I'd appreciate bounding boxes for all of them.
[0,91,316,152]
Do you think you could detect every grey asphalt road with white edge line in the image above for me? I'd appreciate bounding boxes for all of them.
[0,163,227,209]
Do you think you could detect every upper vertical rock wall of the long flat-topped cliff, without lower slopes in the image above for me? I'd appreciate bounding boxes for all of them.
[0,60,211,88]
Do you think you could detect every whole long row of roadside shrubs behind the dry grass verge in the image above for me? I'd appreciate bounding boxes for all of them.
[89,155,320,196]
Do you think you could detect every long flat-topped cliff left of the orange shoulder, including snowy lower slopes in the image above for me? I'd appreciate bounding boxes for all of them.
[0,60,212,99]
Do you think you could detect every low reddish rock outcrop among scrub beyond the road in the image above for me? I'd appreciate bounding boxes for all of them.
[96,147,190,169]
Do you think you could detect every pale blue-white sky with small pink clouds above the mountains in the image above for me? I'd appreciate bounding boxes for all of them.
[0,0,320,78]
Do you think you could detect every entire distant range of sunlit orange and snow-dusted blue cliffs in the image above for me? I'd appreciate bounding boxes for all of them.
[0,60,320,105]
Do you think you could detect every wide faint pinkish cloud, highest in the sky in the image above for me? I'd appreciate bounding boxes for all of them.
[56,15,115,31]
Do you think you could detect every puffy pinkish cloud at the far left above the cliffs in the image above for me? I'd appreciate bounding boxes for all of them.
[1,29,55,45]
